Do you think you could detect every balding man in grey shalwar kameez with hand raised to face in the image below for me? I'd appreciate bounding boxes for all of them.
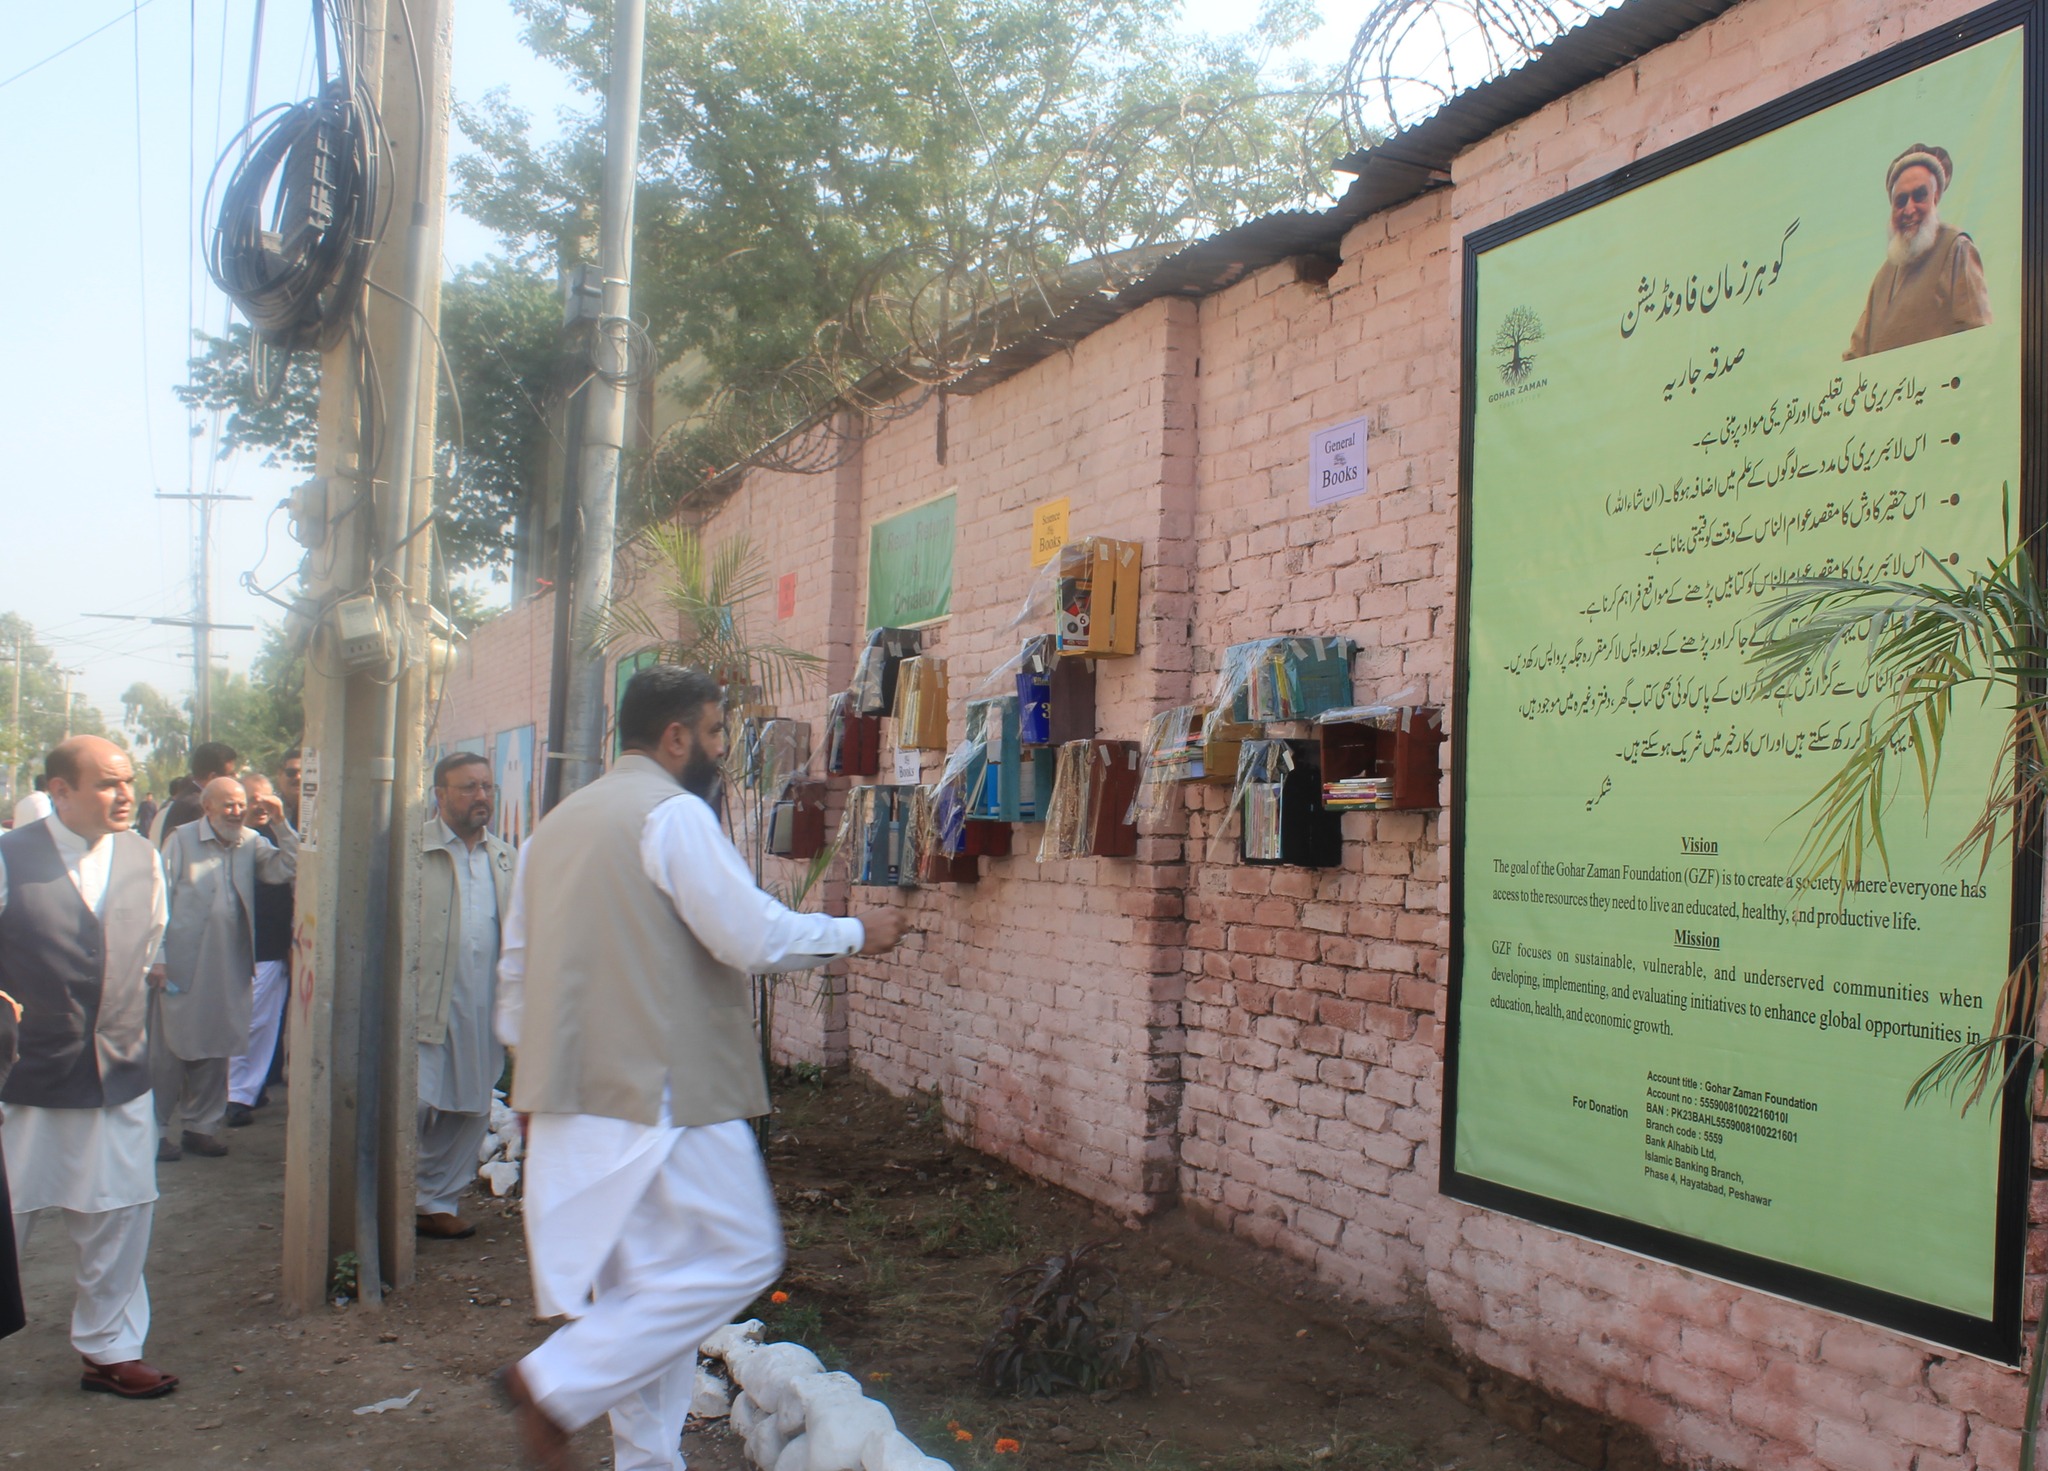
[150,776,299,1164]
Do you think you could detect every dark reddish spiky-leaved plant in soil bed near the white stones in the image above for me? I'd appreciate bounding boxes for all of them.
[975,1242,1171,1395]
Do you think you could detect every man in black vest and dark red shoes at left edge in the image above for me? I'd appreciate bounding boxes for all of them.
[0,736,178,1399]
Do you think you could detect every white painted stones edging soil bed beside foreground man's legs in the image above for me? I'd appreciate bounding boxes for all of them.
[692,1317,952,1471]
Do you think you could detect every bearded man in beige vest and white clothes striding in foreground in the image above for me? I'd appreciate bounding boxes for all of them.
[498,664,903,1471]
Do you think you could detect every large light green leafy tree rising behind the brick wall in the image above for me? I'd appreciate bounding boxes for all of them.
[455,0,1352,510]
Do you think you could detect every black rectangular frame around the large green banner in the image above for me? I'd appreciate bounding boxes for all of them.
[1438,0,2048,1364]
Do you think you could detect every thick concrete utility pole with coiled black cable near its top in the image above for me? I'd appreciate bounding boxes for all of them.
[283,0,453,1311]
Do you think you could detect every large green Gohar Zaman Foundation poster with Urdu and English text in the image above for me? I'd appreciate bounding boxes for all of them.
[1444,8,2042,1358]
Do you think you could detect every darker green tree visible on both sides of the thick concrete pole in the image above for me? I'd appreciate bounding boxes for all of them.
[178,260,563,590]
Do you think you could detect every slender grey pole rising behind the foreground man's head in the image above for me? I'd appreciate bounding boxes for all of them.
[547,0,647,807]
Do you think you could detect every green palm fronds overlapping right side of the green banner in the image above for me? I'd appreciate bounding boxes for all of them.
[1749,486,2048,1471]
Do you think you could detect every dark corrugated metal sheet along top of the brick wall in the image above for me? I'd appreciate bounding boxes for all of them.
[946,0,1741,393]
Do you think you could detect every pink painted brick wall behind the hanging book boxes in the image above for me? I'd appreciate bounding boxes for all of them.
[442,0,2023,1471]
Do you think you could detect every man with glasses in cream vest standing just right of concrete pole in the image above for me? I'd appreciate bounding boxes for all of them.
[414,752,512,1242]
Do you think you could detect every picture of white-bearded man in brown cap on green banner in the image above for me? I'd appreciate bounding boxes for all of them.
[1841,143,1991,359]
